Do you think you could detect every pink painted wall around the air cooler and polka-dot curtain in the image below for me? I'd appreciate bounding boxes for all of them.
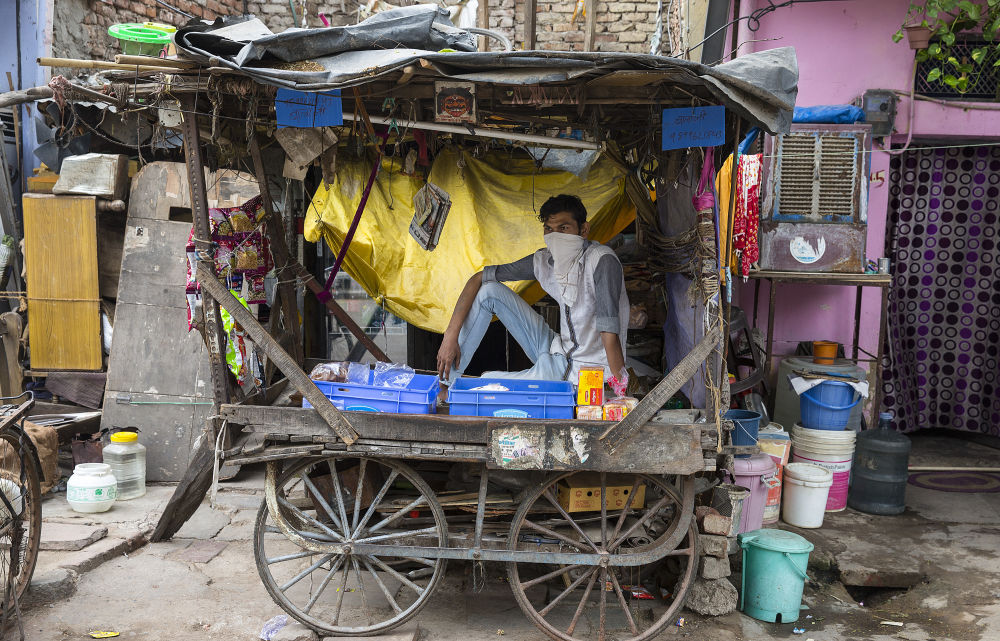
[737,0,1000,410]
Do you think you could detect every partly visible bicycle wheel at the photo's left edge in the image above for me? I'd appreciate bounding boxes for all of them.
[0,430,42,608]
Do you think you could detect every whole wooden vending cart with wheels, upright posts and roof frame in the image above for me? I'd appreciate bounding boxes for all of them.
[127,36,790,641]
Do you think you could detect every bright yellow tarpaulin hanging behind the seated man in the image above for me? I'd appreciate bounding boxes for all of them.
[304,149,635,332]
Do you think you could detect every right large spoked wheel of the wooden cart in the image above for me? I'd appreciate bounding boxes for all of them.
[507,472,697,641]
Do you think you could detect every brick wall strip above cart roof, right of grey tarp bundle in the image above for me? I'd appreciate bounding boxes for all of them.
[481,0,683,55]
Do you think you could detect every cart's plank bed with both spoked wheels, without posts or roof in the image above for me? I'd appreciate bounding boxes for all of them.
[221,405,717,640]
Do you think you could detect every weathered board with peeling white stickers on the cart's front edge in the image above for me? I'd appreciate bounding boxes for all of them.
[486,421,705,474]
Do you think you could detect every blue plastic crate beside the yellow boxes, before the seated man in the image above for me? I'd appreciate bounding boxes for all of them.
[448,378,576,418]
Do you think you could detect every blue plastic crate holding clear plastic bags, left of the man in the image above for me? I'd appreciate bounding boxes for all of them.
[302,372,441,414]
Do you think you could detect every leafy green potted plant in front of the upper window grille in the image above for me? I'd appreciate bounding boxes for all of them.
[893,0,1000,93]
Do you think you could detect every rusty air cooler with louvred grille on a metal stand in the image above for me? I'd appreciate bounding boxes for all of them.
[760,124,872,273]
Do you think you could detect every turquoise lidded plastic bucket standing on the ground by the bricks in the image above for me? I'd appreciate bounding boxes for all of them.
[738,529,813,623]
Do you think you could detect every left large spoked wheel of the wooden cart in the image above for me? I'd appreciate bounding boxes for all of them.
[254,456,448,636]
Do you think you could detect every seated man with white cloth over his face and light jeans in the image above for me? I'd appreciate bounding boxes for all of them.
[437,194,629,392]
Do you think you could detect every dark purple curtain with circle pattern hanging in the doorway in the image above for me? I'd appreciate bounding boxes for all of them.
[883,146,1000,435]
